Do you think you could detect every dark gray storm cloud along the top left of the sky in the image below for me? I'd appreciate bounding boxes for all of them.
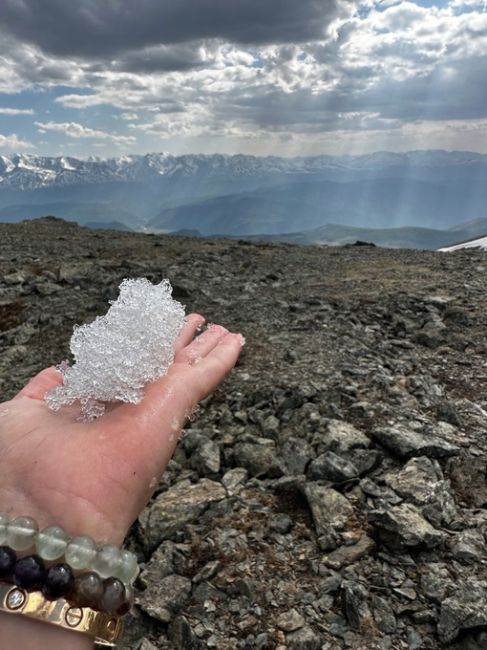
[0,0,353,58]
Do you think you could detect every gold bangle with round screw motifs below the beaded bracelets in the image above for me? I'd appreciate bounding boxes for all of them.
[0,582,122,648]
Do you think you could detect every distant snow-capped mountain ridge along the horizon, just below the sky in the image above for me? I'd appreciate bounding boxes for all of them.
[0,151,487,191]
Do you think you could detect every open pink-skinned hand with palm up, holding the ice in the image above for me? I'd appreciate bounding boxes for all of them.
[0,314,243,544]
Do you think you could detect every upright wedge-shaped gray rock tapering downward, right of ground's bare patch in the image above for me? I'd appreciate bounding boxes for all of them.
[304,483,354,551]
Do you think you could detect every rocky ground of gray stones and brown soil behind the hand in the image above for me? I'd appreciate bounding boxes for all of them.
[0,219,487,650]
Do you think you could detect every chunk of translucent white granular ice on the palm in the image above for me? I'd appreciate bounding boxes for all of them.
[45,278,185,420]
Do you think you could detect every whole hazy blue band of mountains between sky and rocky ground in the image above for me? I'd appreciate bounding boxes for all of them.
[0,151,487,248]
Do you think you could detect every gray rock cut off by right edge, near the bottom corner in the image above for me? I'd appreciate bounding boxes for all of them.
[438,580,487,643]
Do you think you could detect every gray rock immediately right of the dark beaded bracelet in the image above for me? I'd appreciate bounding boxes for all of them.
[136,574,191,623]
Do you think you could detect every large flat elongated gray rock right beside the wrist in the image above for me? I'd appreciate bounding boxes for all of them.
[139,479,227,548]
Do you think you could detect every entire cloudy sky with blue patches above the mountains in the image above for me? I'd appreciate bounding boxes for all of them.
[0,0,487,157]
